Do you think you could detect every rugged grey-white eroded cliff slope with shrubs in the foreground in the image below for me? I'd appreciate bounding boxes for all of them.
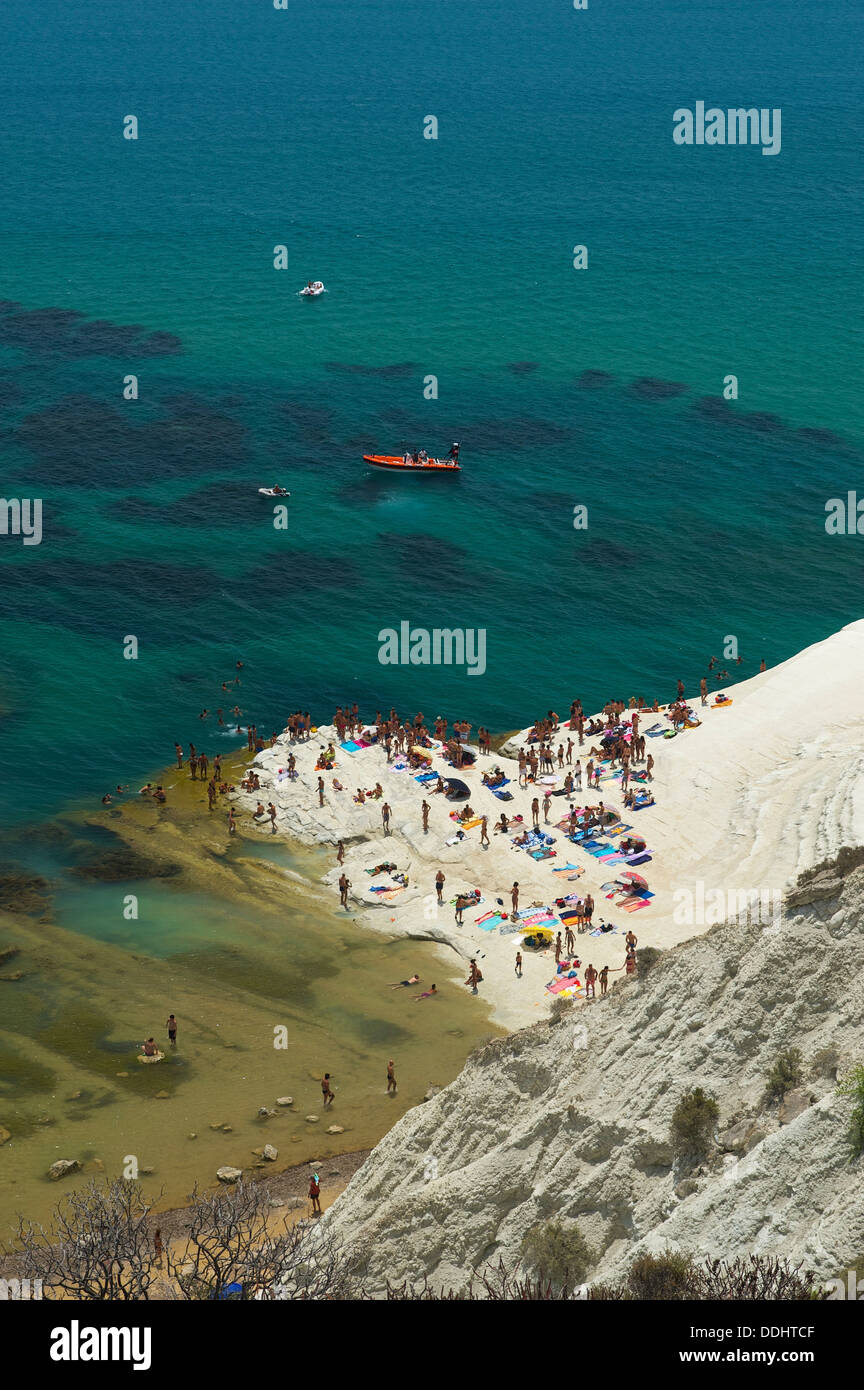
[325,853,864,1293]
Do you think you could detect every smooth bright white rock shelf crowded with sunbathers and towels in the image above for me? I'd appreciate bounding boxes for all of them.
[236,621,864,1027]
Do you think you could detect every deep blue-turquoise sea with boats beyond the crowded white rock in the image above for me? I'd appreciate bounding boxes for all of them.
[0,0,864,823]
